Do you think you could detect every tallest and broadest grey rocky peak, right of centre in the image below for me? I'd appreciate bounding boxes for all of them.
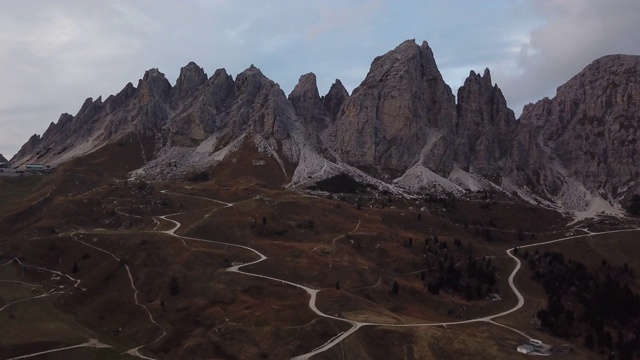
[335,40,456,175]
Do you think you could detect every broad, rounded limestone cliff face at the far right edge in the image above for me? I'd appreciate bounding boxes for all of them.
[512,55,640,204]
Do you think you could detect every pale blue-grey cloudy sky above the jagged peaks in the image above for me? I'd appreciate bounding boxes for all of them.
[0,0,640,157]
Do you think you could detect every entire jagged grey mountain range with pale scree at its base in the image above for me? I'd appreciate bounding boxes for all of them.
[12,40,640,217]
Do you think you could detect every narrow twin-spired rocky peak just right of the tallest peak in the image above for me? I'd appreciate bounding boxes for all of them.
[455,69,516,177]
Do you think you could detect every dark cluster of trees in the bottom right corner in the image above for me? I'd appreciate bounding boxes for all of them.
[521,251,640,359]
